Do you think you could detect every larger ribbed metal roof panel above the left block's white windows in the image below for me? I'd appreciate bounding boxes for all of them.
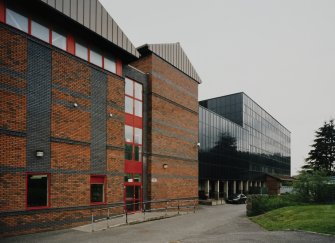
[40,0,140,57]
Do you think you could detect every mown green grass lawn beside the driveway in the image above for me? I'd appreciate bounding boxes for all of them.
[250,204,335,235]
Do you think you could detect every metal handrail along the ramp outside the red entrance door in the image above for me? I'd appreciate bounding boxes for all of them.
[91,198,198,232]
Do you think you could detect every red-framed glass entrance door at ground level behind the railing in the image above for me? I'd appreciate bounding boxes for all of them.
[125,183,142,212]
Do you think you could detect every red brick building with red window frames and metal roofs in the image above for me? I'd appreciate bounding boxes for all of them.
[0,0,201,235]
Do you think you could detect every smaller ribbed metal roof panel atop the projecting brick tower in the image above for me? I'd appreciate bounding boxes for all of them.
[138,43,202,83]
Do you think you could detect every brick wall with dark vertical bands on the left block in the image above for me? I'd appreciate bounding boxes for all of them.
[0,23,124,235]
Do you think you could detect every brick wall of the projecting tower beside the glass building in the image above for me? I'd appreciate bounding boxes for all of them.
[132,54,198,200]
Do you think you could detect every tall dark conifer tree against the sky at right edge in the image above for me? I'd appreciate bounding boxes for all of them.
[303,120,335,175]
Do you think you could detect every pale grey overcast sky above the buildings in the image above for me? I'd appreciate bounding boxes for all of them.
[100,0,335,175]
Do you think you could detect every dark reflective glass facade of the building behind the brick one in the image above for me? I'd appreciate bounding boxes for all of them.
[199,93,291,180]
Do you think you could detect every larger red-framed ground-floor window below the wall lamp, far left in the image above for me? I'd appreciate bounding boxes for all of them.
[27,174,49,208]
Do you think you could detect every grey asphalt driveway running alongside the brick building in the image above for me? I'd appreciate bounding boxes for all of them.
[0,204,335,243]
